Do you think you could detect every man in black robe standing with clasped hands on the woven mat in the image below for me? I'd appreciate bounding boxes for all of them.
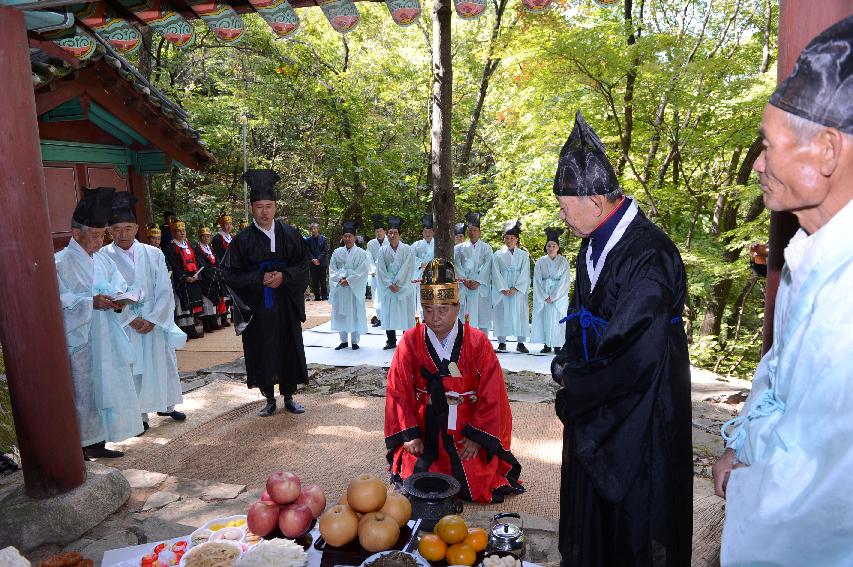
[222,169,309,417]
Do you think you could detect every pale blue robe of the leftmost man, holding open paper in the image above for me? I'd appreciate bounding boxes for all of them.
[54,238,142,446]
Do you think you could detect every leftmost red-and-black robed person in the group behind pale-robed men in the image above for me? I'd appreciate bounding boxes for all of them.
[163,220,204,339]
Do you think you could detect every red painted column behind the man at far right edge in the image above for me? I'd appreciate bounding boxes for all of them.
[762,0,853,353]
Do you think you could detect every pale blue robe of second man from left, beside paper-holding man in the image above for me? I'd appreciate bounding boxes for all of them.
[98,242,187,413]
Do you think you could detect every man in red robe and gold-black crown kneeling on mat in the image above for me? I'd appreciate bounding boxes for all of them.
[385,259,524,503]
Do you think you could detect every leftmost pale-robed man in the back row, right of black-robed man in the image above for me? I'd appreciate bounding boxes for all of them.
[329,221,370,350]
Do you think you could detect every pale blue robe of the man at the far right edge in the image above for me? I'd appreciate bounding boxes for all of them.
[721,202,853,567]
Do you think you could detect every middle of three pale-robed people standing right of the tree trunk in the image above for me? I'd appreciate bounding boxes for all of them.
[492,221,530,354]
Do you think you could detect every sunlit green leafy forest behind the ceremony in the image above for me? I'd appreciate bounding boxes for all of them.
[0,0,778,458]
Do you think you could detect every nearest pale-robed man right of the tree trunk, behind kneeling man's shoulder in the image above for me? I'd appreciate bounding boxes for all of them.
[454,213,494,335]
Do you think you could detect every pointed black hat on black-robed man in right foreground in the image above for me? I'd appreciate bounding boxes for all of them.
[554,110,619,197]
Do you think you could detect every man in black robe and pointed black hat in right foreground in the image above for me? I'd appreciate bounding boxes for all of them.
[552,112,693,567]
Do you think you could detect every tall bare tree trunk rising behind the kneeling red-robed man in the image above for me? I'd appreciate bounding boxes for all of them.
[432,0,456,258]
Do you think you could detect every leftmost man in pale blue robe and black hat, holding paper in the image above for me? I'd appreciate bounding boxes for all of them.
[54,187,143,459]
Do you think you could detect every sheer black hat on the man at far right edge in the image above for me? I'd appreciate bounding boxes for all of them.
[770,16,853,134]
